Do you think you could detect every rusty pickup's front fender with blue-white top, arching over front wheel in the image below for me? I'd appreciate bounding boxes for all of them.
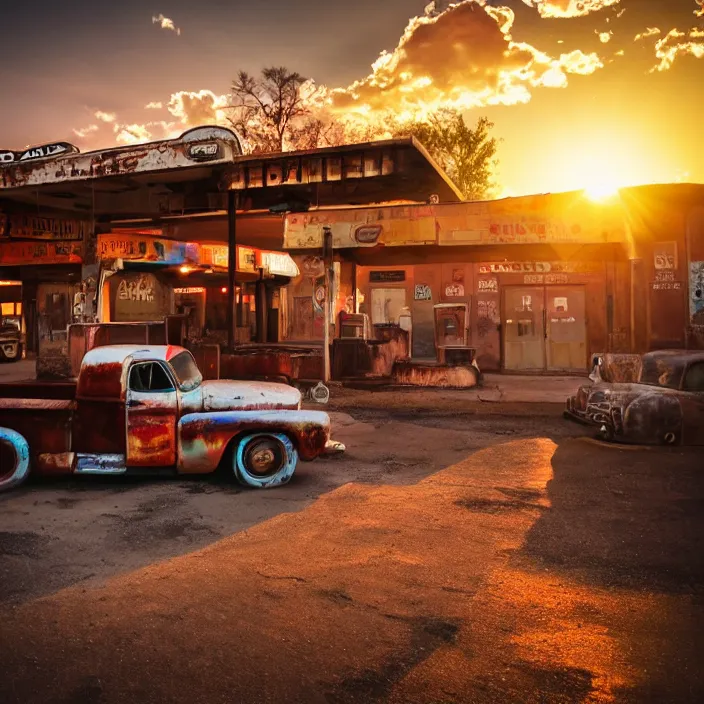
[178,410,330,473]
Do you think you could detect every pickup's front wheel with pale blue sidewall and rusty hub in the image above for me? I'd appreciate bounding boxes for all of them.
[233,433,298,489]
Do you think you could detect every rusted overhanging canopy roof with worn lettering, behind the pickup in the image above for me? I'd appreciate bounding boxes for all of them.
[0,126,461,222]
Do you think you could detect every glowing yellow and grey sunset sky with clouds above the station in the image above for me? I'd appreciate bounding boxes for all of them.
[0,0,704,195]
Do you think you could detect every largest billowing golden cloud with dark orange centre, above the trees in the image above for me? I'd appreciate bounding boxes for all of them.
[330,0,603,119]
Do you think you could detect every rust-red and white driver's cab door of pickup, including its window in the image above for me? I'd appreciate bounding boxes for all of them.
[125,362,178,467]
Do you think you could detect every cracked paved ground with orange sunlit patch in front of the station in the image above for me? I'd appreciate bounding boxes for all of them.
[0,389,704,704]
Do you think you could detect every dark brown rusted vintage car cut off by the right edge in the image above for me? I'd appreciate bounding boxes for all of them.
[565,350,704,445]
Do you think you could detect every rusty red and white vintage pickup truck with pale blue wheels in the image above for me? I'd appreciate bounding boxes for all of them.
[0,345,344,490]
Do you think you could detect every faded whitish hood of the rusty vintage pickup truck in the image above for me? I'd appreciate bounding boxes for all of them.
[201,380,301,413]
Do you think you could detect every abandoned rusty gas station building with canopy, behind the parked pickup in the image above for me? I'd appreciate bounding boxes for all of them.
[0,127,704,386]
